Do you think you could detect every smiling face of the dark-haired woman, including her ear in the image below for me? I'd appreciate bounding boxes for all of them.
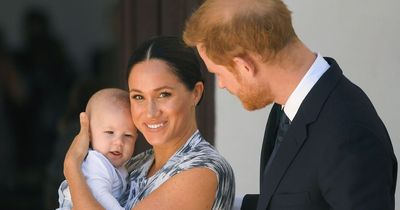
[128,59,203,147]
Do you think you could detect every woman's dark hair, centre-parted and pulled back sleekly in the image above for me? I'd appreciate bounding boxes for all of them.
[127,36,204,94]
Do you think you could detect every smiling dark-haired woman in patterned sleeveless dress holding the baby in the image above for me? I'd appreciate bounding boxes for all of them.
[64,37,235,210]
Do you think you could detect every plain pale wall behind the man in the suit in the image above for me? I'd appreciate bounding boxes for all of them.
[216,0,400,209]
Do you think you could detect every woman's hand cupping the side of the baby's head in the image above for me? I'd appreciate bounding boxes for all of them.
[64,112,90,179]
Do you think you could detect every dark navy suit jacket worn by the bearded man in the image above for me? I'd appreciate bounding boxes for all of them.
[242,58,397,210]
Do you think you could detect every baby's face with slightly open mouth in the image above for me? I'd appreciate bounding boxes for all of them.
[90,105,137,167]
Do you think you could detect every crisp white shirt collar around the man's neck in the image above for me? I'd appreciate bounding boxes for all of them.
[282,53,330,121]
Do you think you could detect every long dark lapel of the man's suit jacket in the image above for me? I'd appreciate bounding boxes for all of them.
[257,58,342,210]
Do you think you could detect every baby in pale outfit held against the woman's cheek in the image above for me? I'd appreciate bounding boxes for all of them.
[58,88,137,209]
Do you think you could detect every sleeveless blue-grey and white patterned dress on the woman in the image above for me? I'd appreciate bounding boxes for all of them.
[125,131,235,210]
